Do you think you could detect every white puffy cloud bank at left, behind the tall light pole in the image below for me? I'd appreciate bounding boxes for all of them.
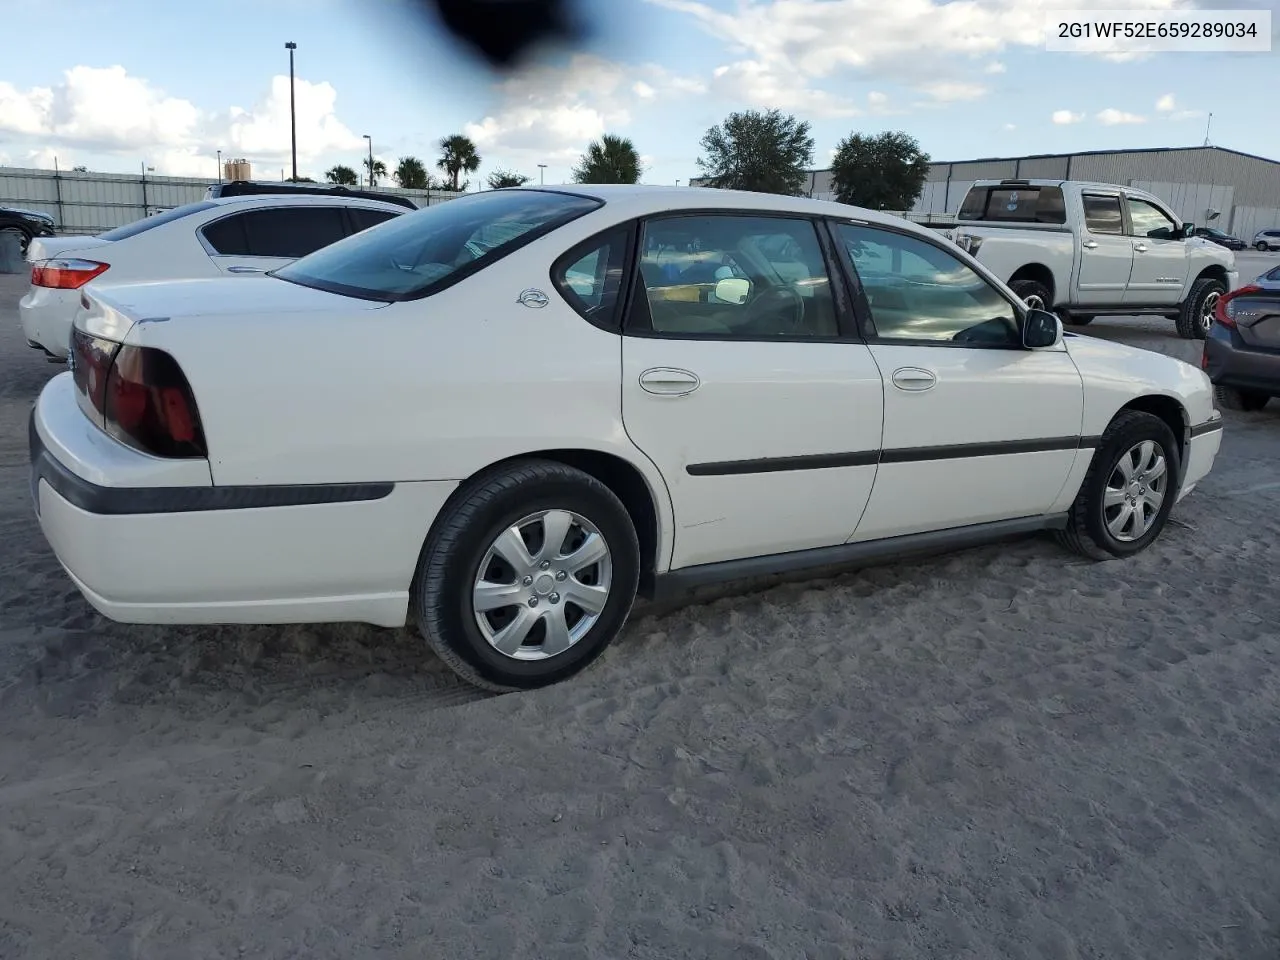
[0,65,364,177]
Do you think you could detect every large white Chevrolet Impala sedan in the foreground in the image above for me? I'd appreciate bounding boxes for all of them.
[31,187,1222,689]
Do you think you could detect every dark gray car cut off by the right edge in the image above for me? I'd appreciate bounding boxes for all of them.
[1201,266,1280,410]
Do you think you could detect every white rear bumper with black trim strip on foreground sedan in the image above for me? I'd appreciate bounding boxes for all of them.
[29,374,456,627]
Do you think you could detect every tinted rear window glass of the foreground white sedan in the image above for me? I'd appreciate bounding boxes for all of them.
[274,189,602,301]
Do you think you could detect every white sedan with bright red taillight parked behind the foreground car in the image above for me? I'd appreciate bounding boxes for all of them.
[18,195,411,361]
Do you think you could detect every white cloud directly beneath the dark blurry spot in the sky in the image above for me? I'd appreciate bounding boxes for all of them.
[462,54,707,165]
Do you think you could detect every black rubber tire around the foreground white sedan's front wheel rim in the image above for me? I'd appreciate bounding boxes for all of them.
[1056,410,1181,561]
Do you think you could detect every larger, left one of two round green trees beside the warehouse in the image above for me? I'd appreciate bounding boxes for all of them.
[698,110,813,196]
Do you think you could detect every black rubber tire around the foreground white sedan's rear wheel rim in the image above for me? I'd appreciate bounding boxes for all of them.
[412,460,640,691]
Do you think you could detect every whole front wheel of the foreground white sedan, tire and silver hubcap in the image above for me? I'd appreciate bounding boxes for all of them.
[1057,410,1180,561]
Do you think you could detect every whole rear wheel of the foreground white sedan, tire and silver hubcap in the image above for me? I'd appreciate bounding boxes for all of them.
[413,460,640,690]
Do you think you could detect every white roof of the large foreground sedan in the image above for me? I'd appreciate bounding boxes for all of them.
[519,183,931,233]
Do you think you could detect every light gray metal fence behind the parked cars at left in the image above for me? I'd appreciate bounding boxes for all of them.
[0,166,461,234]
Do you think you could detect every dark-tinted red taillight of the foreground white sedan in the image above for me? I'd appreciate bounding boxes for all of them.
[72,329,207,458]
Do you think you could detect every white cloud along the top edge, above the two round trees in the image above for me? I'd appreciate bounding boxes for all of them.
[648,0,1187,115]
